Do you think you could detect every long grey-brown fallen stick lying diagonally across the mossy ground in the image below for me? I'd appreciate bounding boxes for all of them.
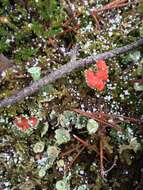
[0,38,143,108]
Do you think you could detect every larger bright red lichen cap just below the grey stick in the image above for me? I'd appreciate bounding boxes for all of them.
[84,60,108,91]
